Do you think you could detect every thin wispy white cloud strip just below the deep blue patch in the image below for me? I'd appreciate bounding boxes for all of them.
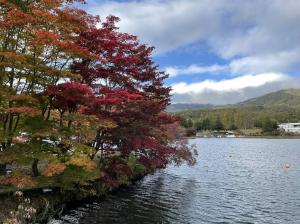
[164,64,227,77]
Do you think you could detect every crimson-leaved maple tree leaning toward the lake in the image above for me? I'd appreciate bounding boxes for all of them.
[71,16,196,181]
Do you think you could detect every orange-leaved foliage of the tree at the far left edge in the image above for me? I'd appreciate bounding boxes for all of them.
[0,0,98,150]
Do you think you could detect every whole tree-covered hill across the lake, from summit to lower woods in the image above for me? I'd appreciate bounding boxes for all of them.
[176,89,300,130]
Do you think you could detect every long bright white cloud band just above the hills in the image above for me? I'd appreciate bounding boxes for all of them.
[172,73,287,94]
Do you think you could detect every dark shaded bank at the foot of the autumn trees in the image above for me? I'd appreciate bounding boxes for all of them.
[0,171,150,224]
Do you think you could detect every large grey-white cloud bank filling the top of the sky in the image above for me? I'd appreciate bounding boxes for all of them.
[88,0,300,74]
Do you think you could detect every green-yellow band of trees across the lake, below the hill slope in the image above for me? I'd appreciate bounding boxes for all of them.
[177,106,300,132]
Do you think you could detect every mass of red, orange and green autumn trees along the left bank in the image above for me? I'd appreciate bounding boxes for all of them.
[0,0,195,220]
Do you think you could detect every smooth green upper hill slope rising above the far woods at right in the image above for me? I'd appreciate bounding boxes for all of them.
[236,89,300,107]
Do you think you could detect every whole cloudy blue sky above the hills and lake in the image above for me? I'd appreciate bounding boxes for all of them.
[84,0,300,105]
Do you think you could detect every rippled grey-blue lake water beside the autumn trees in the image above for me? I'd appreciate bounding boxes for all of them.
[51,139,300,224]
